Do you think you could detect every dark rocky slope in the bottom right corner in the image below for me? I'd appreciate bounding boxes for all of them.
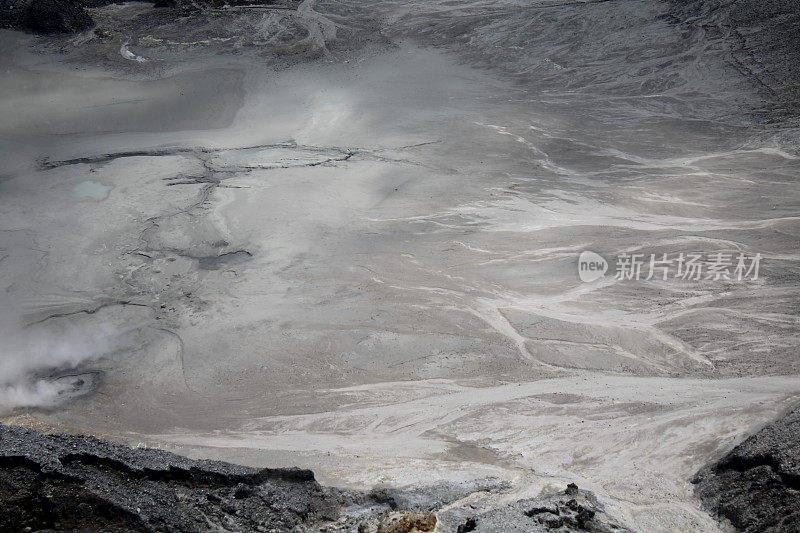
[693,409,800,533]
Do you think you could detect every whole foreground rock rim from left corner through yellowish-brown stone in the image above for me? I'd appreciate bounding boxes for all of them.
[0,424,628,533]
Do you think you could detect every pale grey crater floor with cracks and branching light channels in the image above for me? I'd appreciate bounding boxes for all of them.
[0,0,800,531]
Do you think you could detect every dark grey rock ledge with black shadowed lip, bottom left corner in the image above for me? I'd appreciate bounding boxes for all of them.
[0,426,340,531]
